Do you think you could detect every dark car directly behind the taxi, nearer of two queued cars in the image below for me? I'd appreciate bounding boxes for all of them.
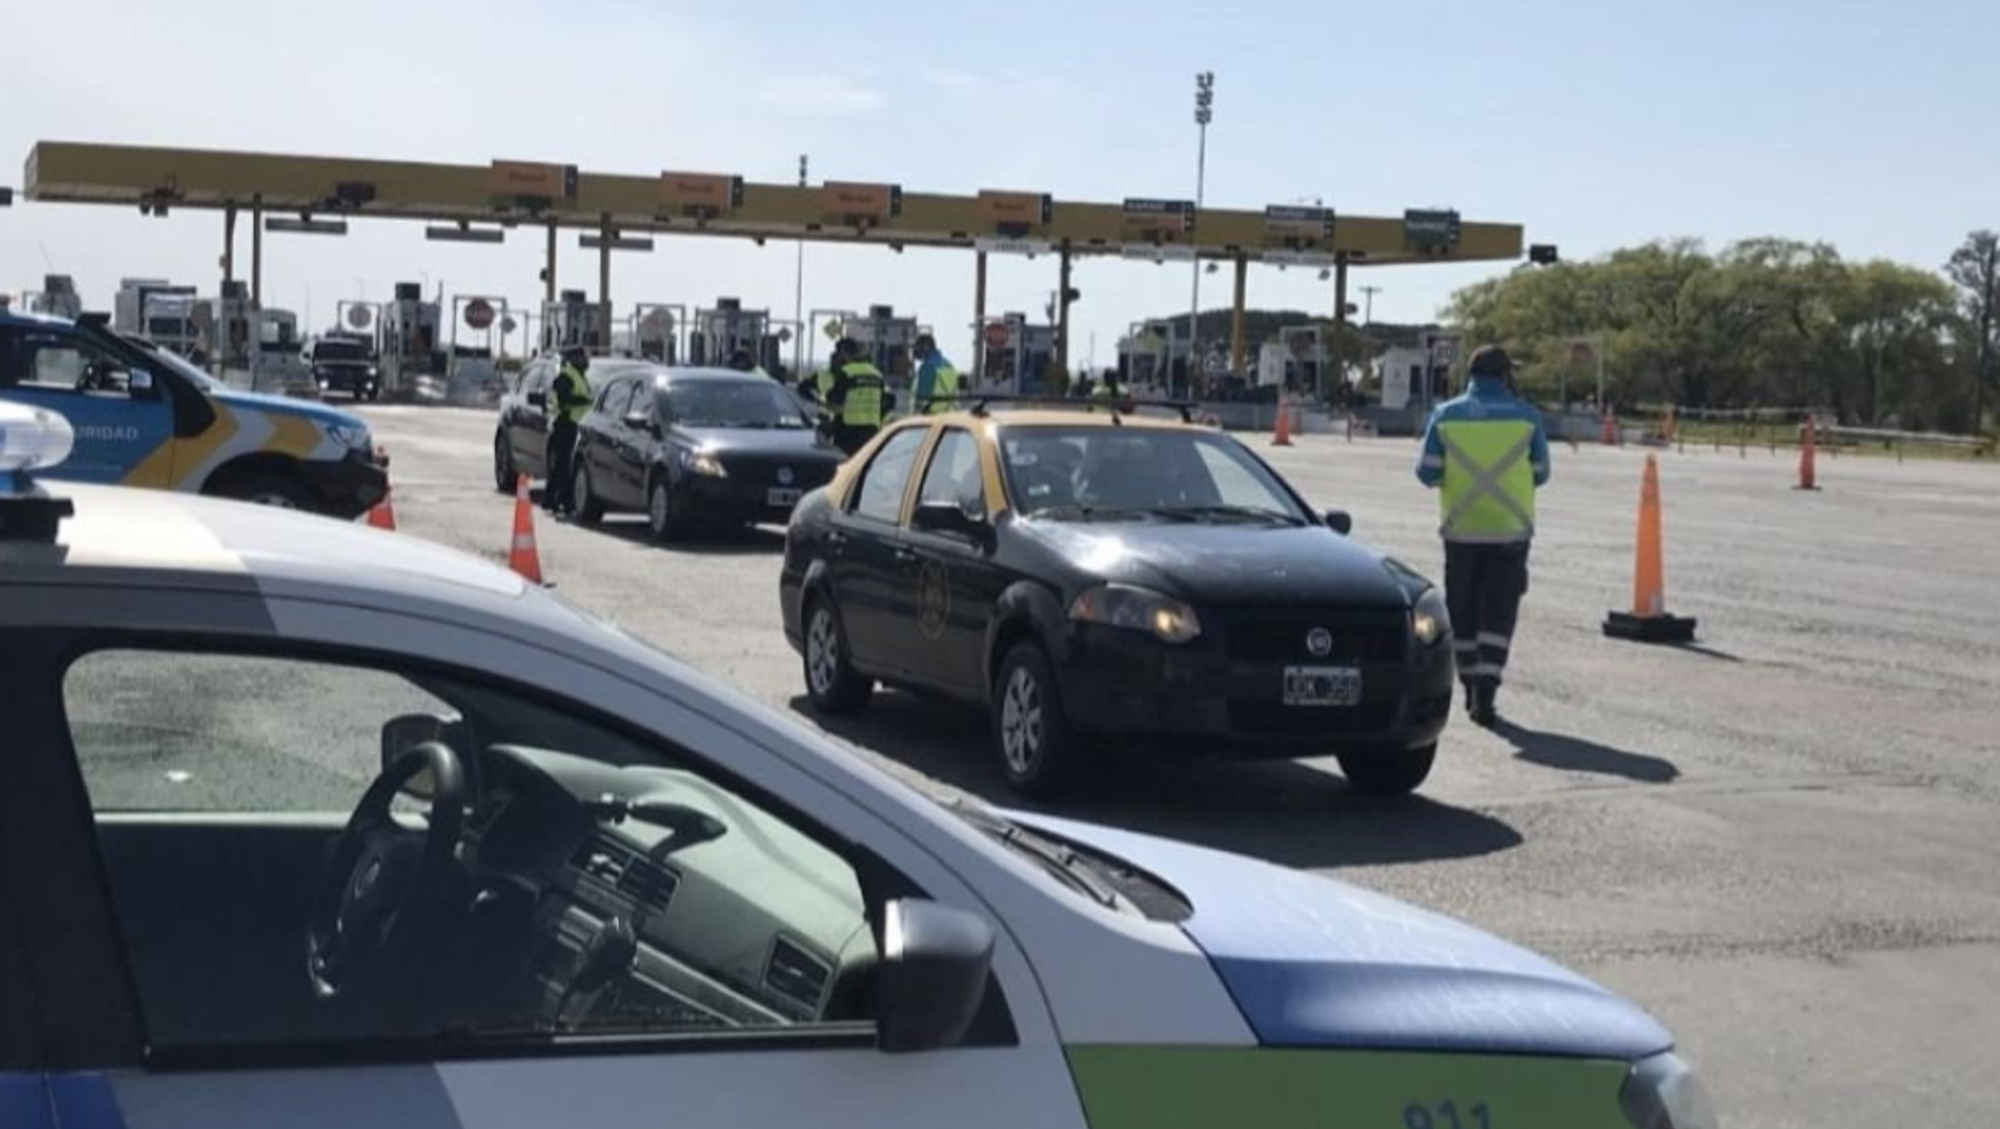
[576,364,846,540]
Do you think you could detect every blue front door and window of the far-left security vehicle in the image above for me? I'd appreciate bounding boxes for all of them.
[0,324,174,486]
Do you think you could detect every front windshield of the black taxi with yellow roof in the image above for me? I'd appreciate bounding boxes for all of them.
[1000,426,1306,524]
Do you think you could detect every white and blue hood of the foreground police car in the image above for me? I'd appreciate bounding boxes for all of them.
[1008,813,1674,1059]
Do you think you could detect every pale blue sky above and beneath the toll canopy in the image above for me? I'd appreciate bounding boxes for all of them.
[0,0,2000,364]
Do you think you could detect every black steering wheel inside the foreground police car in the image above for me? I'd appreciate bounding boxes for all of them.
[306,741,466,999]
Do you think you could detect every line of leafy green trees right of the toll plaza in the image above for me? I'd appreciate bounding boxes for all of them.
[1446,230,2000,430]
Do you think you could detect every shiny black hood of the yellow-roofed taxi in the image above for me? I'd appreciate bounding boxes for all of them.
[1022,518,1410,609]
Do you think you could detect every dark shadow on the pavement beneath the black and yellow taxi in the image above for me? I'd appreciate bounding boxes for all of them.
[790,691,1522,869]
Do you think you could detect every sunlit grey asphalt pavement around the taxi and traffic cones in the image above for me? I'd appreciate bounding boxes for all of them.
[364,406,2000,1127]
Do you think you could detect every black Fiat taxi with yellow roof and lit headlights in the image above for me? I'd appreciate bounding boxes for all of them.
[780,402,1454,795]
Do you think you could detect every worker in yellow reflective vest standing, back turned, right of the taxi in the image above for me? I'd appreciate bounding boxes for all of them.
[1416,346,1548,727]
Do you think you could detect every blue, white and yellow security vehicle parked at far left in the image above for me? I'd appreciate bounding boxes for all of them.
[0,312,388,518]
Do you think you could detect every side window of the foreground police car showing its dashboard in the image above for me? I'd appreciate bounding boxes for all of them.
[64,651,878,1055]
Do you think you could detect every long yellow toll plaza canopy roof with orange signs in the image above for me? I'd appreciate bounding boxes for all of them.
[24,142,1522,266]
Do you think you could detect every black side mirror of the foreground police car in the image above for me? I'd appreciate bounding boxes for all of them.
[876,899,994,1053]
